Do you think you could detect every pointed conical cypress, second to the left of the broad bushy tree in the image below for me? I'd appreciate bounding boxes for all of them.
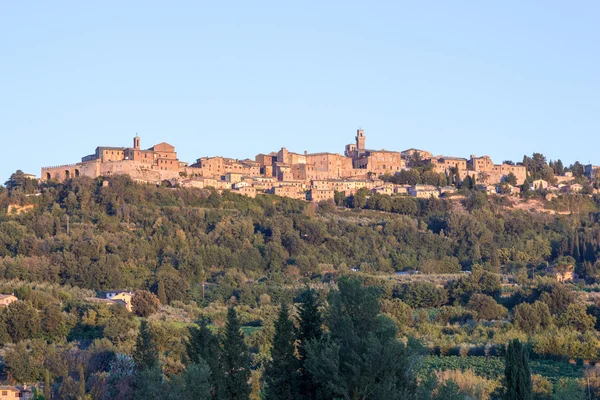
[263,303,299,400]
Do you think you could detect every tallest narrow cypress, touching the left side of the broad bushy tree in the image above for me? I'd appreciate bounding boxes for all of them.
[297,289,323,399]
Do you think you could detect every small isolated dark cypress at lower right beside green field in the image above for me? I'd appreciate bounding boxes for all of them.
[504,339,533,400]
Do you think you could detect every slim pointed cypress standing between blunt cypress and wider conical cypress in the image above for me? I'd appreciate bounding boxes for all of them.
[223,307,251,400]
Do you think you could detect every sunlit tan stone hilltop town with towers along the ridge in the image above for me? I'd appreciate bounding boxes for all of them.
[41,129,599,202]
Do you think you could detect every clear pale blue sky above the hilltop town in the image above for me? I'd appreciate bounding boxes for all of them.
[0,0,600,182]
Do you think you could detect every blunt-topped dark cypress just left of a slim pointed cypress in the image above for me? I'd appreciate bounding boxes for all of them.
[186,319,225,399]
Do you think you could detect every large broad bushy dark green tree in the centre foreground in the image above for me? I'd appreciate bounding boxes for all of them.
[305,277,417,400]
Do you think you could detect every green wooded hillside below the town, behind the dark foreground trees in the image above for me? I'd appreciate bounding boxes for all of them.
[0,177,600,399]
